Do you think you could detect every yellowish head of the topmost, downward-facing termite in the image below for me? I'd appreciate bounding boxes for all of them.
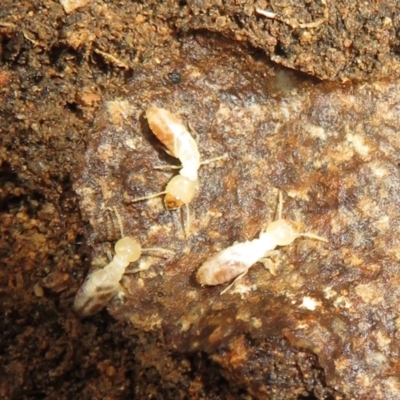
[164,175,197,210]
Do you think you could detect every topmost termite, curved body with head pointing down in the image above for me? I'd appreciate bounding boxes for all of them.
[131,106,227,234]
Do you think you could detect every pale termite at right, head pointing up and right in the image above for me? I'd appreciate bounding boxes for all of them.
[196,192,328,294]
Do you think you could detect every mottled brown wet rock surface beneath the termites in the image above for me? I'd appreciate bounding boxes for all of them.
[74,37,400,399]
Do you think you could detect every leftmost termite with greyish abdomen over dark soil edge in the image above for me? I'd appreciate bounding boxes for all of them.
[74,210,174,317]
